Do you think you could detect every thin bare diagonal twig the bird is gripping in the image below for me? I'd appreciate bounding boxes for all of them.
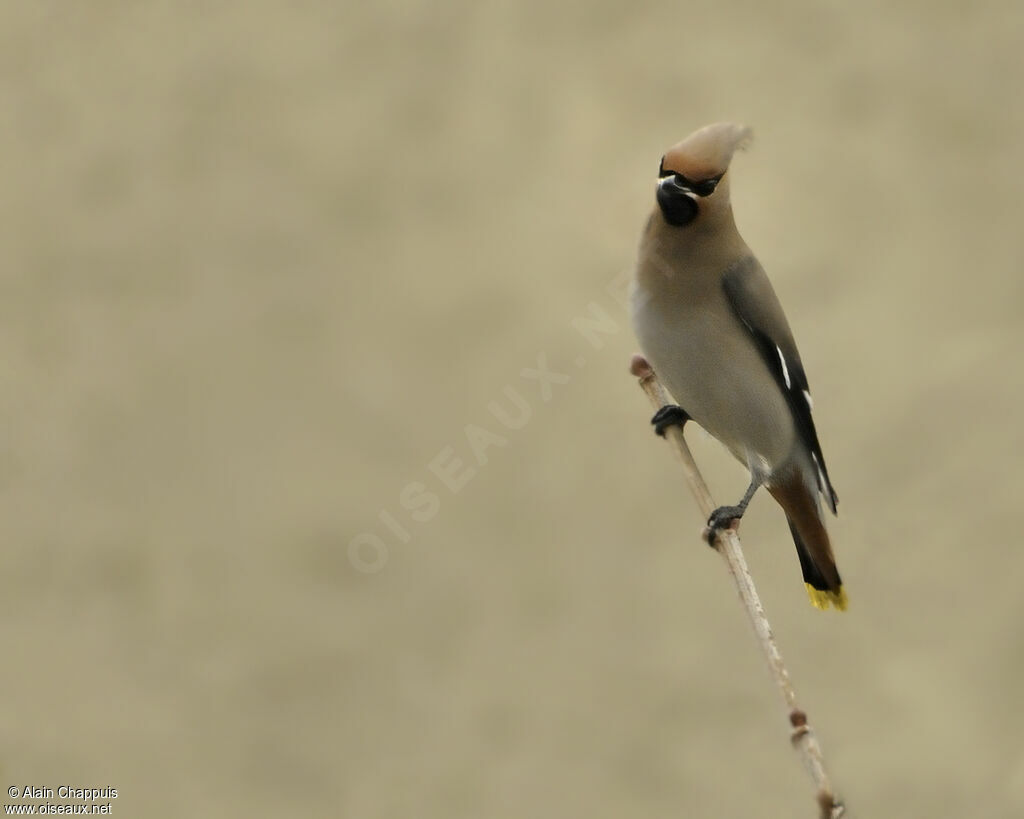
[630,355,846,819]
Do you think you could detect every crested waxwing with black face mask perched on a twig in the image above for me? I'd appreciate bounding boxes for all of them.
[631,122,848,610]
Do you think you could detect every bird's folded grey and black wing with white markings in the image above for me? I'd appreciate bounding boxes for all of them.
[722,256,839,514]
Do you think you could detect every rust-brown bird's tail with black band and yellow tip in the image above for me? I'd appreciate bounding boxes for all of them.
[769,472,847,611]
